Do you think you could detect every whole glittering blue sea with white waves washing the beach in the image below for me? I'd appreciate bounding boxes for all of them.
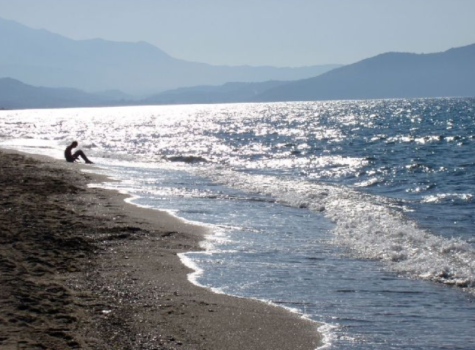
[0,99,475,350]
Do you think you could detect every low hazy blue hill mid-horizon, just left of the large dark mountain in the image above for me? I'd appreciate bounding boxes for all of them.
[140,81,288,104]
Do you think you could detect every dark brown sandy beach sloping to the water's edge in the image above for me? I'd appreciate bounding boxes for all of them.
[0,151,319,350]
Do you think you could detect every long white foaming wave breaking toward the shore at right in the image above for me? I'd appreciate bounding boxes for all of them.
[198,168,475,293]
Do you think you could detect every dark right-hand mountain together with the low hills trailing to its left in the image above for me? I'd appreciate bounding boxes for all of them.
[144,44,475,104]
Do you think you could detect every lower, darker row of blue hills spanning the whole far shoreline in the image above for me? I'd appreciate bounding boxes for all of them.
[4,44,475,109]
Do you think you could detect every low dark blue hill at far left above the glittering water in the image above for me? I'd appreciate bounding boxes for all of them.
[0,78,119,109]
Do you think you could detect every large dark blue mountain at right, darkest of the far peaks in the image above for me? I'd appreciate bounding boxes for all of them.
[254,44,475,102]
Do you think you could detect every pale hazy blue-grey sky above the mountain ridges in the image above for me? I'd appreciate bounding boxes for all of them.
[0,0,475,66]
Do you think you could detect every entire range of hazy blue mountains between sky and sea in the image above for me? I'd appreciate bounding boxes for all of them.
[0,15,475,108]
